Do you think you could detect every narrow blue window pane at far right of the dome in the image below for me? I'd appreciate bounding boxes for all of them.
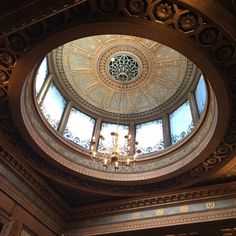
[195,76,206,114]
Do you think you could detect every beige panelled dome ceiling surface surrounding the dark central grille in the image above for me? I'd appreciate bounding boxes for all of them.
[57,35,188,114]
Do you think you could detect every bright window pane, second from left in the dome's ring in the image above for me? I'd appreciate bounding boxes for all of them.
[41,83,66,129]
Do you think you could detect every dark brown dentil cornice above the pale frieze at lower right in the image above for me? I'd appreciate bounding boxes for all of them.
[70,182,236,220]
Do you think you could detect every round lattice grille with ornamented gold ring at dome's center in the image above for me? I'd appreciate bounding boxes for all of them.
[98,44,150,89]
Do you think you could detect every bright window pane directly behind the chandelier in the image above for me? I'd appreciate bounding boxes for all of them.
[98,123,129,155]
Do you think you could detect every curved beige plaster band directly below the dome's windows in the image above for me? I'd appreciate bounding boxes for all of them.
[25,74,216,181]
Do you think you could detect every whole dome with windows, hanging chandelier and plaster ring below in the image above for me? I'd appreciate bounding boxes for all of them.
[26,31,210,181]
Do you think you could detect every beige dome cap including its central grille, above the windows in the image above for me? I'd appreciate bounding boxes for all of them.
[53,35,193,117]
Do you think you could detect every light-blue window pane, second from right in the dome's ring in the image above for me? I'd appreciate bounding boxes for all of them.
[169,101,194,144]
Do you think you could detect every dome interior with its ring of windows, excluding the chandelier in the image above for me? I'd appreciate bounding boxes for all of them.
[32,35,207,167]
